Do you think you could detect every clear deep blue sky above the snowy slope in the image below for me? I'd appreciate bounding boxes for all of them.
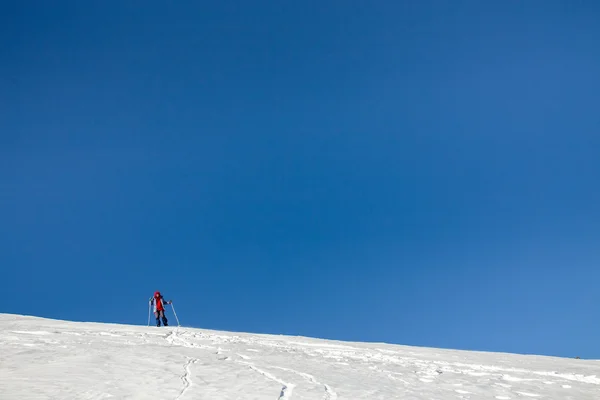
[0,1,600,358]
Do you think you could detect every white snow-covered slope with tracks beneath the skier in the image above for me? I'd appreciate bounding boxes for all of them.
[0,314,600,400]
